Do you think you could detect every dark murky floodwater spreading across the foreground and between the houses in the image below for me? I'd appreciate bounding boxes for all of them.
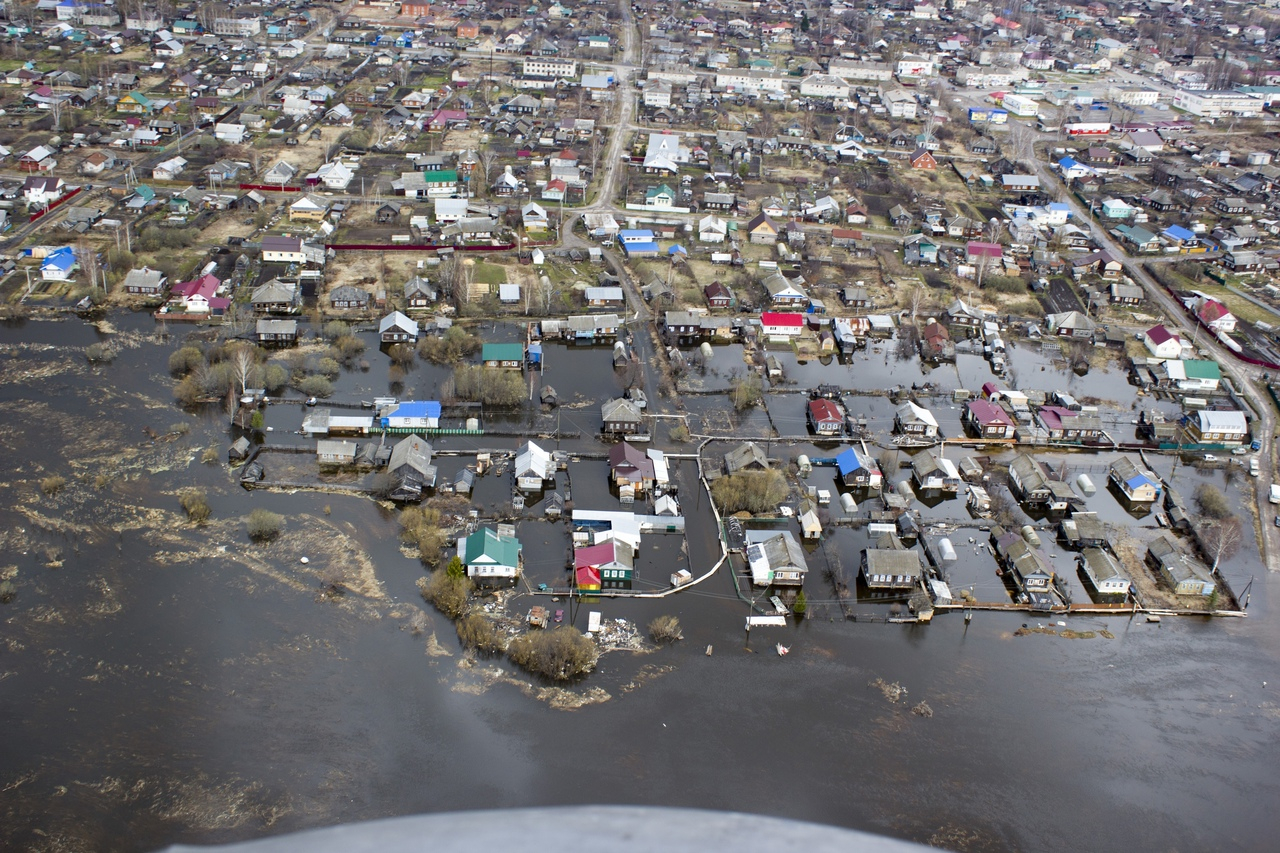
[0,316,1280,850]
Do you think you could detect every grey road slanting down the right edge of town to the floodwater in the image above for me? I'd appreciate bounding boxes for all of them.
[1036,160,1280,571]
